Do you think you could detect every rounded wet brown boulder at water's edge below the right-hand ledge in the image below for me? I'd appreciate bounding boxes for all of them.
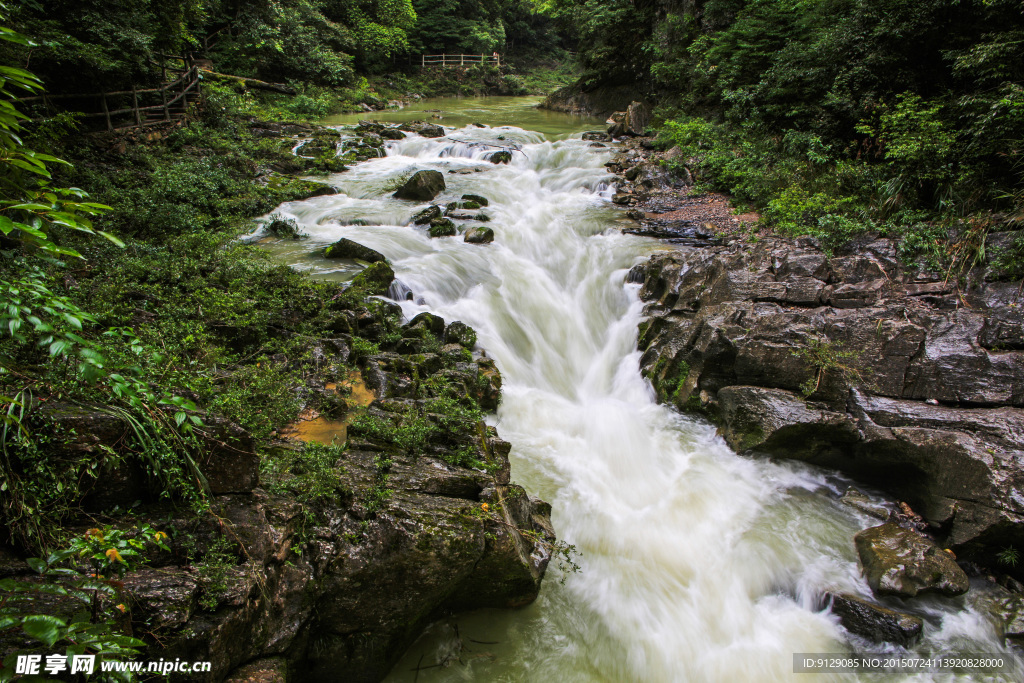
[854,522,970,598]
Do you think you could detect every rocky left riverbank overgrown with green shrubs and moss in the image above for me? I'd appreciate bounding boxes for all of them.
[2,88,559,681]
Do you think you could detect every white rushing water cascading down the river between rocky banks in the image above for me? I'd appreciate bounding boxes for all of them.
[258,109,1005,682]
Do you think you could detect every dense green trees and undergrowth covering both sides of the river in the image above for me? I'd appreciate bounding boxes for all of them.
[0,0,1024,681]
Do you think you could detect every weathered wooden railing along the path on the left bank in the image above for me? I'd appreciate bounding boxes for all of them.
[16,66,203,130]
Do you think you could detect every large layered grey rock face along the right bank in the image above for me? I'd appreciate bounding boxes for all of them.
[631,239,1024,561]
